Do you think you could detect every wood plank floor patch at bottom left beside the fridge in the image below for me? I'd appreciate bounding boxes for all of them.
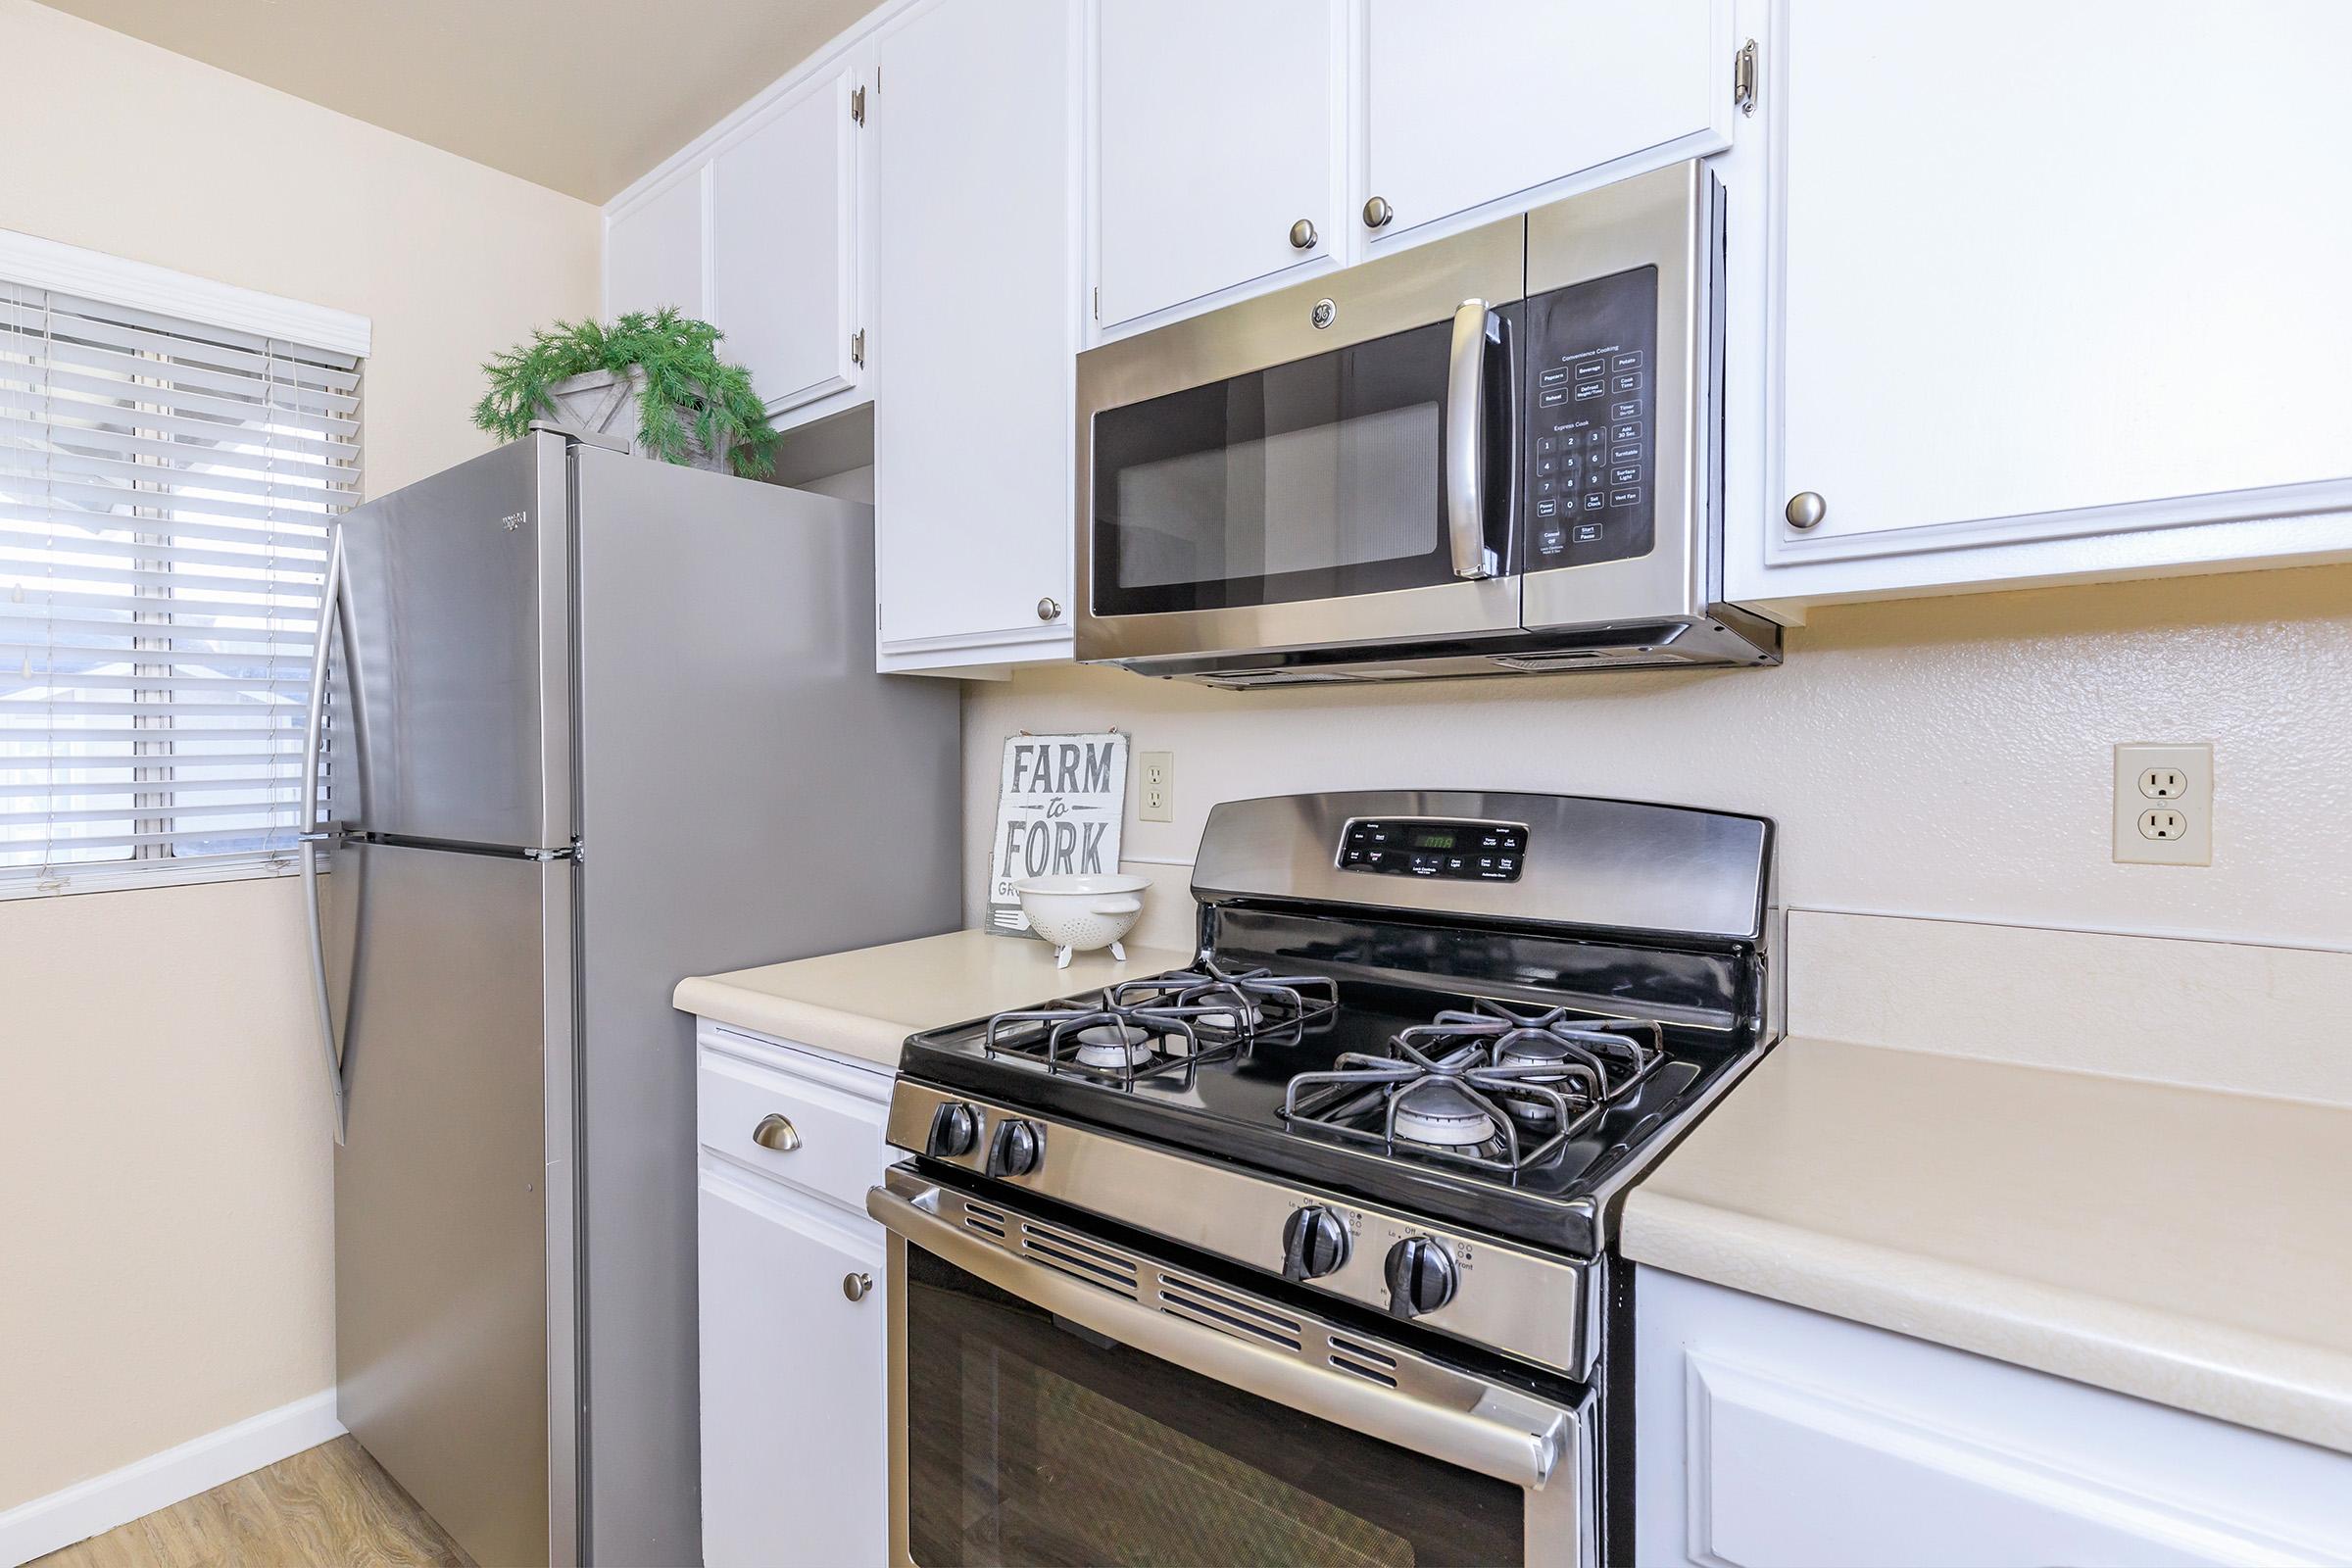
[35,1437,472,1568]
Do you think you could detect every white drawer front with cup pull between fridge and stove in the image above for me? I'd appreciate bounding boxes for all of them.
[696,1049,889,1215]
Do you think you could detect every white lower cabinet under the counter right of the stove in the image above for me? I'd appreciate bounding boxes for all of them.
[1635,1269,2352,1568]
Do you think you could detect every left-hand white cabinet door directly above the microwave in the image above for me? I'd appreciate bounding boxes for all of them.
[1094,0,1346,326]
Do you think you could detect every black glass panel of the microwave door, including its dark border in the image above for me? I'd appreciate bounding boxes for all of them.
[1092,319,1507,615]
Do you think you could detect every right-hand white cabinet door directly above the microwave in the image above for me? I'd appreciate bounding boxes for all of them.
[1348,0,1734,240]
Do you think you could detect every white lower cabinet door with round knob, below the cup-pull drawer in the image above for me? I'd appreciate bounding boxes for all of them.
[699,1171,889,1568]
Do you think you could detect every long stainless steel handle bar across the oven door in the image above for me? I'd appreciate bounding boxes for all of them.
[865,1173,1581,1491]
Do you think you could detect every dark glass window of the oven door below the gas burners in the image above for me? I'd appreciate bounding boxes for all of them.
[906,1246,1524,1568]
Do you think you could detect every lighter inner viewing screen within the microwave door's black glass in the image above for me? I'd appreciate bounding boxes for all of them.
[1117,402,1442,588]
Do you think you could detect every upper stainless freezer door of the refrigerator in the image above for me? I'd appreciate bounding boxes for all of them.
[336,435,571,849]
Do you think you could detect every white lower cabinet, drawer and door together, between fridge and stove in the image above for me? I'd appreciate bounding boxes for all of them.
[696,1022,889,1568]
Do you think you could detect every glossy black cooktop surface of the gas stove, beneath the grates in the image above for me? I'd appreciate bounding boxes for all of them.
[901,955,1752,1253]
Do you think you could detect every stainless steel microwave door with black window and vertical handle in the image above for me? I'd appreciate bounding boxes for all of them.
[1075,219,1527,661]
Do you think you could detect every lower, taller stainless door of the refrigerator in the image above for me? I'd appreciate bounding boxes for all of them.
[322,842,576,1563]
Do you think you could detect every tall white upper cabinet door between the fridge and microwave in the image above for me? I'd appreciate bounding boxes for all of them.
[872,0,1077,659]
